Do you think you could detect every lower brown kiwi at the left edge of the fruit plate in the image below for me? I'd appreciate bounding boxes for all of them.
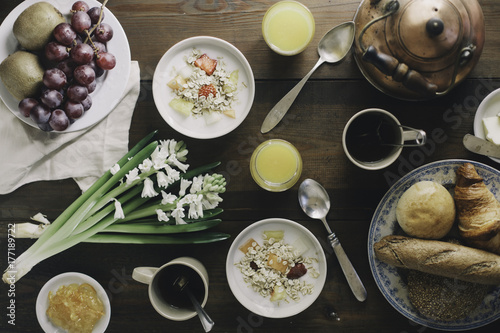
[0,51,44,100]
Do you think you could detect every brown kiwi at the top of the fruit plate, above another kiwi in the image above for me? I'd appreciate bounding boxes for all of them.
[13,2,66,51]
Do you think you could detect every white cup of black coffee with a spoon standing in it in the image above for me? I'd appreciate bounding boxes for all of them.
[132,257,208,321]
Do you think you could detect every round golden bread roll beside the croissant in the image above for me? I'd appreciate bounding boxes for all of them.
[396,181,455,239]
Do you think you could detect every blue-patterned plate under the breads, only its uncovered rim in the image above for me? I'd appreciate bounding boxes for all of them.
[368,160,500,331]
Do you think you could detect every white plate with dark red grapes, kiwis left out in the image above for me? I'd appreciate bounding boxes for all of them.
[0,0,130,132]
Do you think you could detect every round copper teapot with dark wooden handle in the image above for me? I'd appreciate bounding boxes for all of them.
[354,0,485,100]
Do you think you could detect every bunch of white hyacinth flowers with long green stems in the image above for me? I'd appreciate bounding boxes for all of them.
[2,132,229,283]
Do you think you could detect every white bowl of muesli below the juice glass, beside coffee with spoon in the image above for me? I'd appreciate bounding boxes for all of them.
[226,218,327,318]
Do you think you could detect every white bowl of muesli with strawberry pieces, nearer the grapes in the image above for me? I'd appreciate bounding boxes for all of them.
[153,36,255,139]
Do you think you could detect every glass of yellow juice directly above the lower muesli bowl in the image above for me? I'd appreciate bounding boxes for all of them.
[250,139,302,192]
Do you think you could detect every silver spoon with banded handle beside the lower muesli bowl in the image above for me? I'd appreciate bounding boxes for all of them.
[299,179,366,302]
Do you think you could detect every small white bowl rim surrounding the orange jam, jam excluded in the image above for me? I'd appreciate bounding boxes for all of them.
[36,272,111,333]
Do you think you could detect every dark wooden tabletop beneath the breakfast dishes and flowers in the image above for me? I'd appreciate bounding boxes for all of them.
[0,0,500,333]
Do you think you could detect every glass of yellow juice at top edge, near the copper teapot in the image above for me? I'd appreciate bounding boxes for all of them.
[262,0,315,56]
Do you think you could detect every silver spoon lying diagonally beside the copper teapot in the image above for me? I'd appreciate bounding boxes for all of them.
[260,21,354,133]
